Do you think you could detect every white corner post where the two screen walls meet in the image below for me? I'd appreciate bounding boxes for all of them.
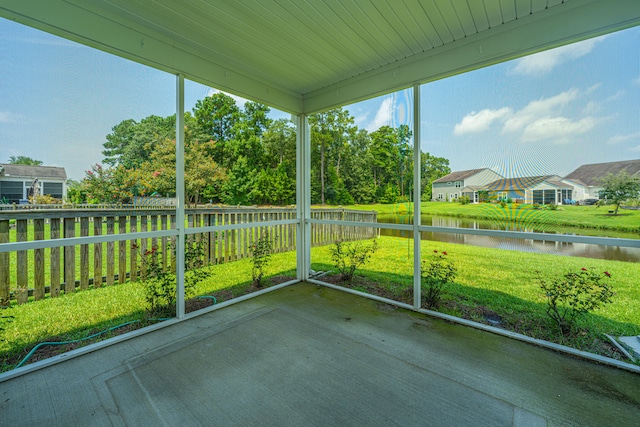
[296,114,311,280]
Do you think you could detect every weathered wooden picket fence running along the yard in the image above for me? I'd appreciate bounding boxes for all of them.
[0,206,377,306]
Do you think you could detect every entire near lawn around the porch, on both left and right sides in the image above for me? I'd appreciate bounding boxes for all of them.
[0,237,640,370]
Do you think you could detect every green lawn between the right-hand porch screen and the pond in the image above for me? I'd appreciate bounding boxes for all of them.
[312,237,640,358]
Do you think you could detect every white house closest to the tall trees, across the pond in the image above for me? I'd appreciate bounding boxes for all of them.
[431,168,502,202]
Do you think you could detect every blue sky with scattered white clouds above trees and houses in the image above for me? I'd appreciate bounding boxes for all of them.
[0,19,640,179]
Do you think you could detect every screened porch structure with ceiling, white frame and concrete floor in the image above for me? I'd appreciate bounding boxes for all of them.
[0,0,640,426]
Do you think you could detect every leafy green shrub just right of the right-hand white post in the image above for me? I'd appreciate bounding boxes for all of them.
[420,250,457,308]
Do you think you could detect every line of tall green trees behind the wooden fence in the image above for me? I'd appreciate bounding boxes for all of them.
[68,93,451,205]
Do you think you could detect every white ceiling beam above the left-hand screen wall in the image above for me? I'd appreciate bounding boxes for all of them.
[0,0,302,113]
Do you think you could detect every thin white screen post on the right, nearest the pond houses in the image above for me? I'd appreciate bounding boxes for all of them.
[413,84,422,309]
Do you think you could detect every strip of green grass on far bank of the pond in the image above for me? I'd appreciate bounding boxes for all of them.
[345,202,640,234]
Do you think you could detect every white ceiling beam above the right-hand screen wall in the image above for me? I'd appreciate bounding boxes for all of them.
[304,0,640,114]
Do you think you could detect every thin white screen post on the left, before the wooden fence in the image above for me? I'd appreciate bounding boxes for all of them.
[175,74,185,319]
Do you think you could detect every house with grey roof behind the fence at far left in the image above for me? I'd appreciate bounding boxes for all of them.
[0,163,67,203]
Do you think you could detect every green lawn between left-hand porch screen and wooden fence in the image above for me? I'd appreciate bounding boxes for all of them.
[0,252,296,371]
